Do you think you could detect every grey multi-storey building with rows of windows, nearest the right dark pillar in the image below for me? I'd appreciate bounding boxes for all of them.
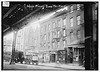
[40,4,85,63]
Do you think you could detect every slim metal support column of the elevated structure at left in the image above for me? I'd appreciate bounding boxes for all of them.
[10,28,18,64]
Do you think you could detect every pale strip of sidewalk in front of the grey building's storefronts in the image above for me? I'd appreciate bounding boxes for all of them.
[39,63,85,70]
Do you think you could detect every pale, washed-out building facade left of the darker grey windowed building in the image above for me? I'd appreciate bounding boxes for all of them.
[15,25,40,56]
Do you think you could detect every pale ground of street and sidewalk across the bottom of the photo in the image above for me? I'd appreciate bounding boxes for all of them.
[3,62,85,71]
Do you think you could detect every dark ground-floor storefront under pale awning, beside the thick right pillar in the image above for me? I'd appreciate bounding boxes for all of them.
[66,44,85,65]
